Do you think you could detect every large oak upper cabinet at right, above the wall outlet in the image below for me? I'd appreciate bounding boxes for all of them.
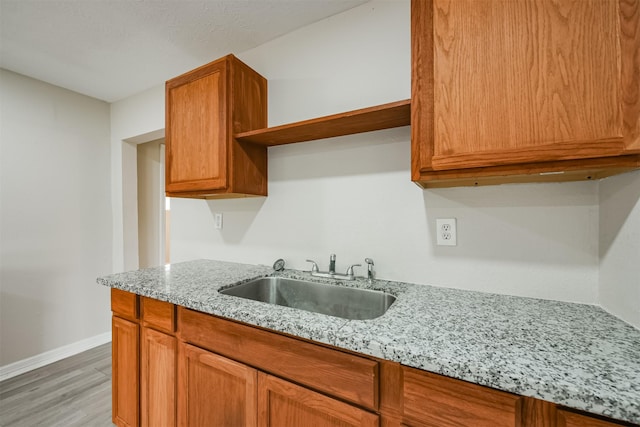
[411,0,640,187]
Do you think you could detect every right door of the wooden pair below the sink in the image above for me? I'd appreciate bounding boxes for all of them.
[258,372,379,427]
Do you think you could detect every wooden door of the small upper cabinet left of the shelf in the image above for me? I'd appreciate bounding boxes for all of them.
[165,60,229,192]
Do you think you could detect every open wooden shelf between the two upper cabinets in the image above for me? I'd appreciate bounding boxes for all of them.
[234,99,411,146]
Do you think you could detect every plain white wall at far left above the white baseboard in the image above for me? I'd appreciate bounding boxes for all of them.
[0,70,112,366]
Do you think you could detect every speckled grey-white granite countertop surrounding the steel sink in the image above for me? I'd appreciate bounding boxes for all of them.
[97,260,640,423]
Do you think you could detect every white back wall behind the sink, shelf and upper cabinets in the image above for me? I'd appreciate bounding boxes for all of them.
[107,0,640,327]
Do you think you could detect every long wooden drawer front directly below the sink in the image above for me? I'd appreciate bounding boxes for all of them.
[178,307,378,409]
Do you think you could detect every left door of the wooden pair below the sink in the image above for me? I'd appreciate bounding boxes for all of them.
[178,343,257,427]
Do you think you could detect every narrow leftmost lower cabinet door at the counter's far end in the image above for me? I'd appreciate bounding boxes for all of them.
[111,316,139,427]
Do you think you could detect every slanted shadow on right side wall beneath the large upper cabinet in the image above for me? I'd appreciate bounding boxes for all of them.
[600,171,640,257]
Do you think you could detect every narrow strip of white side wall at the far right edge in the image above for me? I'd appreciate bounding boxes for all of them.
[599,171,640,328]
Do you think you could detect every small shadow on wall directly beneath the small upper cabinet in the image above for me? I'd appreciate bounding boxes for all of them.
[207,197,266,244]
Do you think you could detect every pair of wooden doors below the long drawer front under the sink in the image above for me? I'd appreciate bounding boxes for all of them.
[178,343,379,427]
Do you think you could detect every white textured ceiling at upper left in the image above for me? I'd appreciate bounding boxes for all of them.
[0,0,367,102]
